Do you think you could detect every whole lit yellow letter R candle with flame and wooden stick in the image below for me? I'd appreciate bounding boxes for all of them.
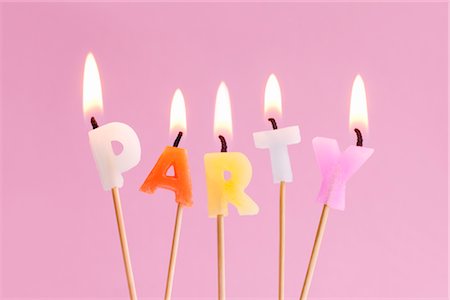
[204,82,259,300]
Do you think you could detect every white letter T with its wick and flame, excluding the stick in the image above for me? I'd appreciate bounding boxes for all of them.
[253,74,300,183]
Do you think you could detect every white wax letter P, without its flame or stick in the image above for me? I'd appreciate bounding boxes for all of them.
[89,122,141,191]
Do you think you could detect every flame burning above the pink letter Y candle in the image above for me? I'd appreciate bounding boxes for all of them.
[349,74,369,131]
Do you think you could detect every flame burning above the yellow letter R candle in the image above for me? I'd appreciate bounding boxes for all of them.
[214,81,233,138]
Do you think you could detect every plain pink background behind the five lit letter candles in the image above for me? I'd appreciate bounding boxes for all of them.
[0,3,448,299]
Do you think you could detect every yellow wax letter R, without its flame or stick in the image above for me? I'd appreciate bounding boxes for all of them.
[204,152,259,217]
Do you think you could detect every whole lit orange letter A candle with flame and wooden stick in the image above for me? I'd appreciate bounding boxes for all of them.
[140,89,192,300]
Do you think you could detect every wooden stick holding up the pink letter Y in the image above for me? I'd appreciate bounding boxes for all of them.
[300,204,329,300]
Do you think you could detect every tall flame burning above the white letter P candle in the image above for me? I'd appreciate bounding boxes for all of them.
[83,52,103,117]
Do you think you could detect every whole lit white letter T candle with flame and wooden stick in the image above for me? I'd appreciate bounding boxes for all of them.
[253,74,300,300]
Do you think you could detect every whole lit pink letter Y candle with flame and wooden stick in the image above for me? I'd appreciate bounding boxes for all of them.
[300,75,374,300]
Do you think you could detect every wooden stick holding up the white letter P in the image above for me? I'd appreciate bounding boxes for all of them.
[112,187,137,300]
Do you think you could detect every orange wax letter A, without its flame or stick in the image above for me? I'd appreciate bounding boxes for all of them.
[140,146,193,206]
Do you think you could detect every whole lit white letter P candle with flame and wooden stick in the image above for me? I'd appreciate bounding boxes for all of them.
[83,53,141,300]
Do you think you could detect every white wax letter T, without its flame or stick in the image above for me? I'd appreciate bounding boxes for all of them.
[253,126,300,183]
